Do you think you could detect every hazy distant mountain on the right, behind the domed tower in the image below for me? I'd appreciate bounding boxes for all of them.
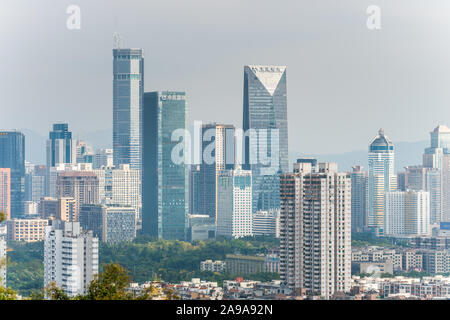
[290,141,429,172]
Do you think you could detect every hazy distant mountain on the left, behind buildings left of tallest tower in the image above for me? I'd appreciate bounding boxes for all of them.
[20,129,112,164]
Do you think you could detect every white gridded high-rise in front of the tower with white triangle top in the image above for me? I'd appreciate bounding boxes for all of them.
[216,167,253,238]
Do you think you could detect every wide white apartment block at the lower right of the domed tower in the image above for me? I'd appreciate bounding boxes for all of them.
[384,190,431,236]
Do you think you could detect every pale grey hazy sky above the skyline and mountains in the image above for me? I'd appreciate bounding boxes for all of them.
[0,0,450,154]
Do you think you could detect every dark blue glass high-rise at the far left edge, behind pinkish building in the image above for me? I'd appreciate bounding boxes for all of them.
[0,131,25,218]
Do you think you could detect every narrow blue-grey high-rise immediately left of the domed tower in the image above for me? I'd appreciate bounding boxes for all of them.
[350,166,368,232]
